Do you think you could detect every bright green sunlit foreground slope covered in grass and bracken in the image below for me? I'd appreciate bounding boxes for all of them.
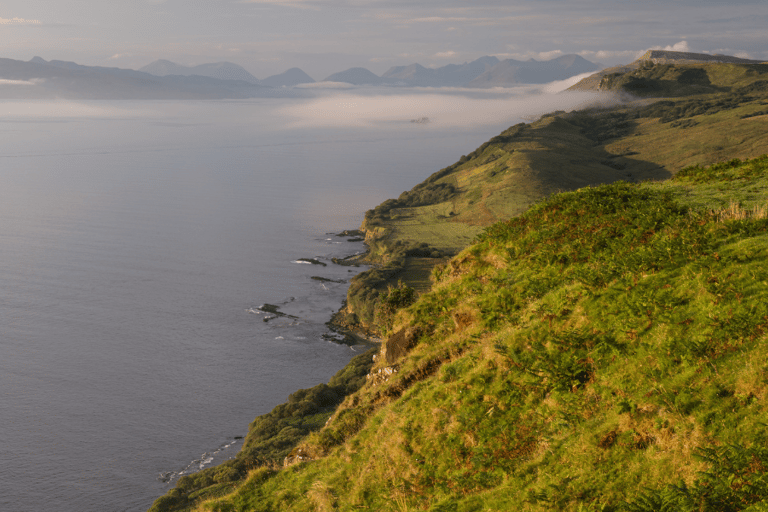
[180,157,768,511]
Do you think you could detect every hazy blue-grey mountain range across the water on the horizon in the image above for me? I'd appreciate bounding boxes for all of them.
[0,55,599,99]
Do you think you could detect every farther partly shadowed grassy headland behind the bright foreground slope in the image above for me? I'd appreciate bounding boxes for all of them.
[338,58,768,330]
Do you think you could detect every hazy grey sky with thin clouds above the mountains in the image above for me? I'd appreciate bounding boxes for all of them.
[0,0,768,79]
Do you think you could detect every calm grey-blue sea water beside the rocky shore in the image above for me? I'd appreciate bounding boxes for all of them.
[0,93,518,512]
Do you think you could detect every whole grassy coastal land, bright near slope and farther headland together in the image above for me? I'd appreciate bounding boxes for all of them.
[152,59,768,512]
